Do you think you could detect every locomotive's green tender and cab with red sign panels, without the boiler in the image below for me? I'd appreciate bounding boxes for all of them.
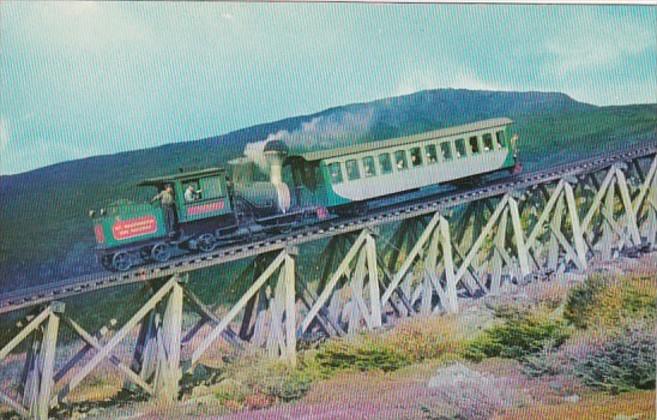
[90,168,234,271]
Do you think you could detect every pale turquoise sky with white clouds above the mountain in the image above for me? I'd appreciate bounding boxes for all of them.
[0,1,657,174]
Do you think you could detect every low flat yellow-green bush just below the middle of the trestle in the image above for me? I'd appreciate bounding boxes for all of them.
[315,340,409,372]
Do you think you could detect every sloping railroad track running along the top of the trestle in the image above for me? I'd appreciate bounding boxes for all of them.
[0,142,657,314]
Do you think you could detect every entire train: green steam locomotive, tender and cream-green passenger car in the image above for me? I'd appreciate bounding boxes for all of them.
[90,118,520,271]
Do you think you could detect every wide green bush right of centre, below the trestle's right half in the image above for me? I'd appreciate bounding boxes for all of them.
[465,308,570,361]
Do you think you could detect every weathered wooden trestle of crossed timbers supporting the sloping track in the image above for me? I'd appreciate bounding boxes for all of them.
[0,156,657,418]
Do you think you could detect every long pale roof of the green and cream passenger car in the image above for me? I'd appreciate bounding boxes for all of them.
[288,117,513,161]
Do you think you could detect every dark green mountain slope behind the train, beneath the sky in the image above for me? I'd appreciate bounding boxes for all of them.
[0,89,657,289]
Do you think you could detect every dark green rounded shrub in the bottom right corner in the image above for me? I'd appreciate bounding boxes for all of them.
[574,324,657,392]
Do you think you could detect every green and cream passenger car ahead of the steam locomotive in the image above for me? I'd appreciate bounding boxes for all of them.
[288,118,517,208]
